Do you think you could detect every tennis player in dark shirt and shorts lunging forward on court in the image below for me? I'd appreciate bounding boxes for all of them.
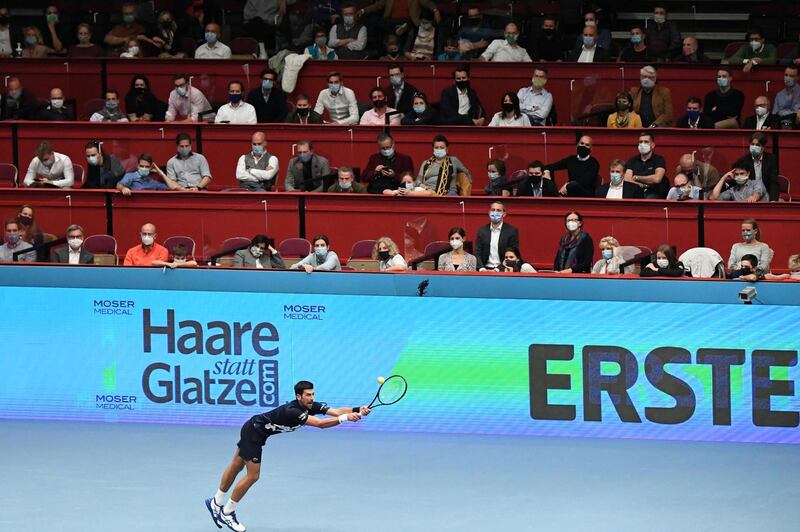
[206,381,370,532]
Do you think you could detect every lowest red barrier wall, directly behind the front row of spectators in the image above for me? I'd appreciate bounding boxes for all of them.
[0,189,800,272]
